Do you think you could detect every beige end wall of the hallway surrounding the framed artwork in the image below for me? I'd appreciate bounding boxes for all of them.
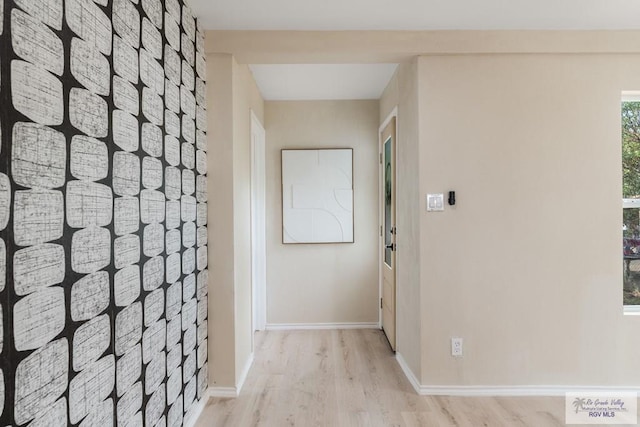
[265,101,379,324]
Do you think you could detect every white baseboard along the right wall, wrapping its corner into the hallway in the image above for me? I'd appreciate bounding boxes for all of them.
[396,352,640,397]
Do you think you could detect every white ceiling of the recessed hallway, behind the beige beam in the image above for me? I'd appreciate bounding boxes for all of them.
[249,64,397,101]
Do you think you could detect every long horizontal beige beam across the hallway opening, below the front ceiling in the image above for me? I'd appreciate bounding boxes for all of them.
[205,30,640,64]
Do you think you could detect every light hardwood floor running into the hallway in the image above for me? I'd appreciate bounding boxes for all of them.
[196,330,600,427]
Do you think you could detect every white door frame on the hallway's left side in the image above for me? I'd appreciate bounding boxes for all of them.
[251,110,267,340]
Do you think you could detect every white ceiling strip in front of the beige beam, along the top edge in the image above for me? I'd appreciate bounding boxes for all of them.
[191,0,640,31]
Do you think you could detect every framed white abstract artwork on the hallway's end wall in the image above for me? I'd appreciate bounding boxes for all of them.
[282,148,354,244]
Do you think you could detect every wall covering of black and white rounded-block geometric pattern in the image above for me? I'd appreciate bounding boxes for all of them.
[0,0,208,427]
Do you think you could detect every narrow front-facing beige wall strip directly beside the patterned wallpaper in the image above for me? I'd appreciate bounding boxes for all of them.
[207,55,235,387]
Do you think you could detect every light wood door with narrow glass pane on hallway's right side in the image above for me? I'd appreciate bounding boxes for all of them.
[380,111,397,351]
